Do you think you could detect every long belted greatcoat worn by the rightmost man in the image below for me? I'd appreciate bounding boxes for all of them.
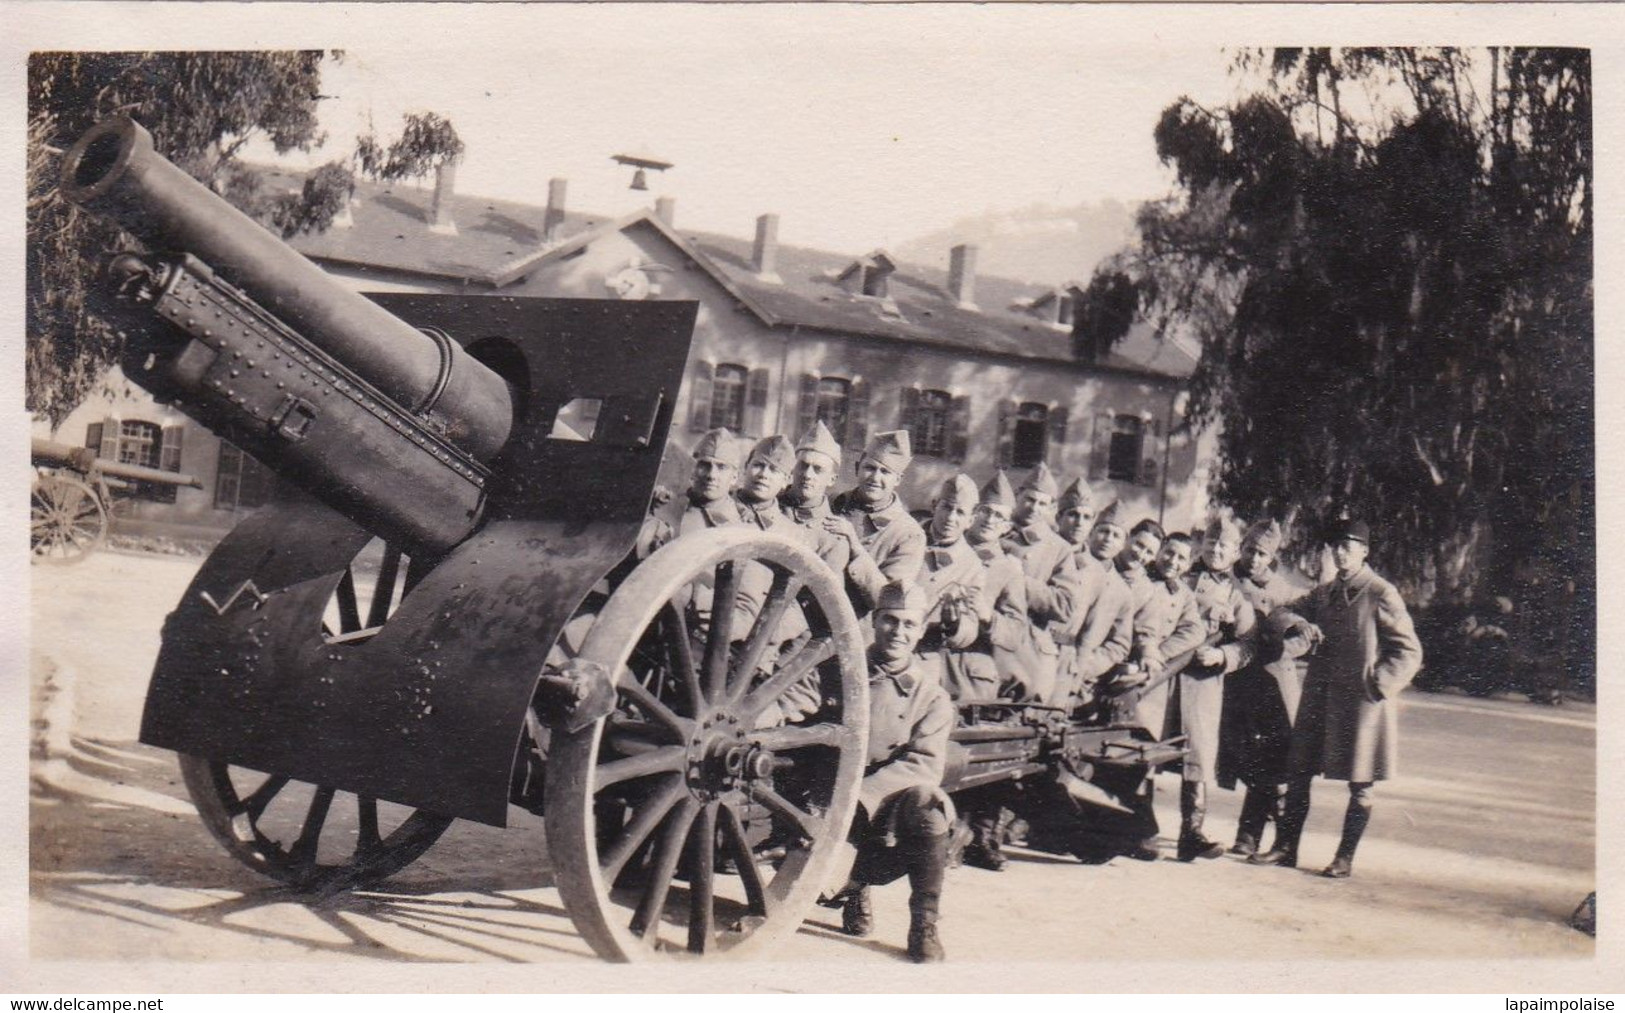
[1285,566,1422,780]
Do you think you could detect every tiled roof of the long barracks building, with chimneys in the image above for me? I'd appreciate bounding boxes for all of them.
[265,169,1194,377]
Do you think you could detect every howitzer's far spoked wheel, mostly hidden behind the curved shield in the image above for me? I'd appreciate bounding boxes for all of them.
[180,541,452,891]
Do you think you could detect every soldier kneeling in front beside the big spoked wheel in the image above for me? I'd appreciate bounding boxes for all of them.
[780,582,954,963]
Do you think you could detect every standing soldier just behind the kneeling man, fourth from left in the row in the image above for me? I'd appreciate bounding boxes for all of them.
[824,429,925,618]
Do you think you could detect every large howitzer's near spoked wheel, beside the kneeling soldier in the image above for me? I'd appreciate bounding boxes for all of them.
[546,527,869,961]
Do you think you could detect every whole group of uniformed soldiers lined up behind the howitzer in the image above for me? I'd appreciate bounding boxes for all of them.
[639,423,1420,961]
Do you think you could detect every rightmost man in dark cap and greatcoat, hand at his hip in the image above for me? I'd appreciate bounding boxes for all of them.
[1251,520,1422,880]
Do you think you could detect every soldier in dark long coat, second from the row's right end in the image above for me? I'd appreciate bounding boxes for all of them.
[1217,519,1307,859]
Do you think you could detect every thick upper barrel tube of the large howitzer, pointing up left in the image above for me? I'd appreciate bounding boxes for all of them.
[60,117,514,460]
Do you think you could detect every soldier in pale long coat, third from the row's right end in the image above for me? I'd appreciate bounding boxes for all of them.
[1177,517,1256,862]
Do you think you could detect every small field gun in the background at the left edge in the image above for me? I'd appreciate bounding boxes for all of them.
[28,436,203,563]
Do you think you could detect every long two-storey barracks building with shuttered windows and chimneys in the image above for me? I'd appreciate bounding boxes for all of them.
[36,167,1212,538]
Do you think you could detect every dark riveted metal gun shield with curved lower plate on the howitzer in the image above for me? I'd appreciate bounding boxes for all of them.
[141,296,694,826]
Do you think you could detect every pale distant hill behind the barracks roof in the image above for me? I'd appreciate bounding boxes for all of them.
[889,200,1134,285]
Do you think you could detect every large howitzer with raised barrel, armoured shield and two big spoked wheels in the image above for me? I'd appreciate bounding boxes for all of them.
[62,119,868,959]
